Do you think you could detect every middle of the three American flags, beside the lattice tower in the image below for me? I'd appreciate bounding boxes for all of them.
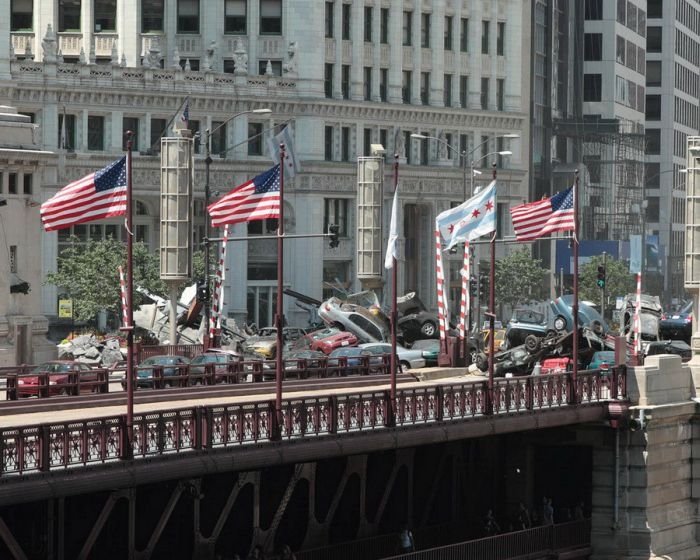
[207,164,280,227]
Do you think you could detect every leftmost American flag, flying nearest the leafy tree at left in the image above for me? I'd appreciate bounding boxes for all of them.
[41,156,126,231]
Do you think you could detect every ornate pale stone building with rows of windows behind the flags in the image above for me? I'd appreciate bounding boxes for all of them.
[0,0,530,336]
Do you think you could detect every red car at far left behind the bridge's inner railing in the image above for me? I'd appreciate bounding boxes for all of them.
[17,360,99,398]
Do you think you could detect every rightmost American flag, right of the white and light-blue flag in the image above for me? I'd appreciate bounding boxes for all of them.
[510,186,576,242]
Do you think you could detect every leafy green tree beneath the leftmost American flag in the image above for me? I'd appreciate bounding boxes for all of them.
[44,237,172,321]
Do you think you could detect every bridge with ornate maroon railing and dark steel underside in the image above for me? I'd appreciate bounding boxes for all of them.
[0,356,694,558]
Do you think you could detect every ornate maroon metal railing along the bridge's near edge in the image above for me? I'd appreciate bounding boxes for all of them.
[0,369,625,477]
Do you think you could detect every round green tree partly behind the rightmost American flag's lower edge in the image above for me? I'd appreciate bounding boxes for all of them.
[496,247,547,307]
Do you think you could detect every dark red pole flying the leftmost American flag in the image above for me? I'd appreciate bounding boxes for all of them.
[122,130,134,458]
